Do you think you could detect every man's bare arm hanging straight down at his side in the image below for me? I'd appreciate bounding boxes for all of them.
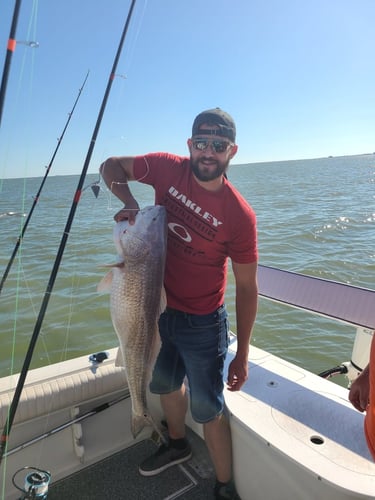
[228,262,258,391]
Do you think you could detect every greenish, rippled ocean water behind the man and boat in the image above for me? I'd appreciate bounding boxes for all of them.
[0,155,375,385]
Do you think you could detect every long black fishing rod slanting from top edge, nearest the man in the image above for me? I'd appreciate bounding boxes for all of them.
[0,0,136,464]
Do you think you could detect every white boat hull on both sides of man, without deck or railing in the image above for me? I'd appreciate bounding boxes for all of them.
[0,340,375,500]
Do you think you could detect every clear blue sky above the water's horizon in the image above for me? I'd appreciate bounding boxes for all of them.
[0,0,375,178]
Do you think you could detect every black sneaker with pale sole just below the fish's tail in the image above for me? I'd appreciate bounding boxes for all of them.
[139,444,192,476]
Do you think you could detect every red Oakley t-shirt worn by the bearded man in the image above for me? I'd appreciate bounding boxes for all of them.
[134,153,257,314]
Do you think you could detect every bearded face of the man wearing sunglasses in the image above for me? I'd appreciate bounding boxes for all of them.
[188,125,237,182]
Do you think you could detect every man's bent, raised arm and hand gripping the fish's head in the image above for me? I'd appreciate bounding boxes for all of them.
[99,156,139,224]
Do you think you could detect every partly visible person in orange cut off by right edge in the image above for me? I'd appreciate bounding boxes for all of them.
[349,335,375,460]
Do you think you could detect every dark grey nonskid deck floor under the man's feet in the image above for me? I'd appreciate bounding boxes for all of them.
[48,430,215,500]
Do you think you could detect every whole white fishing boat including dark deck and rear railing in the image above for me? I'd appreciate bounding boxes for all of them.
[0,266,375,500]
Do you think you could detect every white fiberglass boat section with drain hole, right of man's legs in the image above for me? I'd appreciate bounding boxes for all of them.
[226,340,375,500]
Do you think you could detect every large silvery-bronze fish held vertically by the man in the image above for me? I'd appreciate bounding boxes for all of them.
[98,205,167,437]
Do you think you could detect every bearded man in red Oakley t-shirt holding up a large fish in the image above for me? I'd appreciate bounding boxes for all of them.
[100,108,258,499]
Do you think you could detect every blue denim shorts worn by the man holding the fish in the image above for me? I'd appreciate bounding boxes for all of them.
[150,305,229,423]
